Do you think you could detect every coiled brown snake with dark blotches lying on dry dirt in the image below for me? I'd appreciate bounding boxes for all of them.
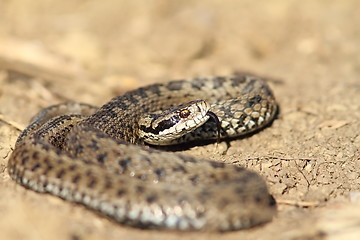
[7,73,278,232]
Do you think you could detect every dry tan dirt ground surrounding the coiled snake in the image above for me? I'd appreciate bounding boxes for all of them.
[0,0,360,240]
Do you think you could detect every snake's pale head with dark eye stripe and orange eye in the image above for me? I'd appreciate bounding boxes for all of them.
[139,100,210,145]
